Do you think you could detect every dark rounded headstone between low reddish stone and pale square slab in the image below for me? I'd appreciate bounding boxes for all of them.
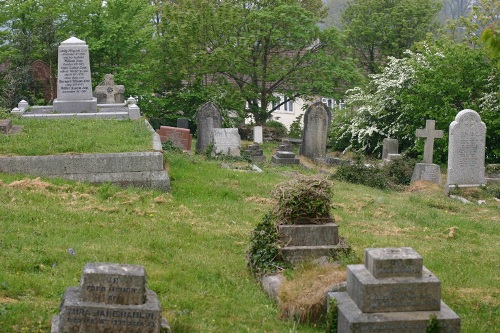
[196,102,222,154]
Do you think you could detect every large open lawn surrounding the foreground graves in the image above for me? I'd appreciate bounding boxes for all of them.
[0,153,500,333]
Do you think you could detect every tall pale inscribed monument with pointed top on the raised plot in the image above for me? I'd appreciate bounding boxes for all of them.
[54,37,97,113]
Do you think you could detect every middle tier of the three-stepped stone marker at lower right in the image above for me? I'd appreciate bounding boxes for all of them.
[347,265,441,312]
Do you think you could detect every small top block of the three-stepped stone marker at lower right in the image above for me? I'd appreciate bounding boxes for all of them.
[365,247,423,279]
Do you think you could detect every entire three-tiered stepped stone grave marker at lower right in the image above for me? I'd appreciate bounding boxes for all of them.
[327,247,460,333]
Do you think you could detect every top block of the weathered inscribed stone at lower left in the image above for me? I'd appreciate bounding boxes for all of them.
[80,263,147,305]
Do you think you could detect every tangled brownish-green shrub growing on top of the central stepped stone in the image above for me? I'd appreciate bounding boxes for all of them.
[273,176,332,224]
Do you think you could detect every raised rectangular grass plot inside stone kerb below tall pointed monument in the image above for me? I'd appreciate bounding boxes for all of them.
[0,118,152,156]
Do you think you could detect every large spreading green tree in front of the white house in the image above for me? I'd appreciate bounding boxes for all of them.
[156,0,357,123]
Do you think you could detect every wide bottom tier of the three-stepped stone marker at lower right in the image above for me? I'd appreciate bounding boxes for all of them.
[327,292,460,333]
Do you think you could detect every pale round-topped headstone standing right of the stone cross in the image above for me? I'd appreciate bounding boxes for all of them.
[446,110,486,187]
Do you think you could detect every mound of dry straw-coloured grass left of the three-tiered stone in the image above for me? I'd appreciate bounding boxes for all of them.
[278,265,346,322]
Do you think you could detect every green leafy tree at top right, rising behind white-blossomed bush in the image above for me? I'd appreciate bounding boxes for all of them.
[342,0,440,73]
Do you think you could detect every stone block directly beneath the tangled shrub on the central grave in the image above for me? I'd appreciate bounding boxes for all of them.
[278,223,339,246]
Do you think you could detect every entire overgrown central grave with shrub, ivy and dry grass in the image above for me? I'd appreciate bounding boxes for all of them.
[247,175,350,321]
